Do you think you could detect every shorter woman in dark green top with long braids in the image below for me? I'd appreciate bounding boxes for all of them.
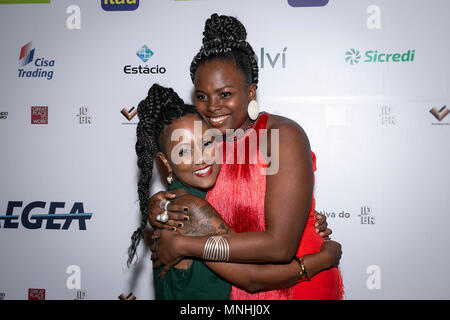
[128,84,341,300]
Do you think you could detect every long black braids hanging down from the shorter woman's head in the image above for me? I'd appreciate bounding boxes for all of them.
[127,83,200,267]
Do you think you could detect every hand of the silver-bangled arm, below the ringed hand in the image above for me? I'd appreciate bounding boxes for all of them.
[150,229,183,279]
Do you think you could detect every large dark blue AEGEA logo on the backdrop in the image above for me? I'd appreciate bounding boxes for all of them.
[0,201,92,230]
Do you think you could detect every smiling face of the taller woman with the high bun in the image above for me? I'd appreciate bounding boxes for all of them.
[194,59,256,134]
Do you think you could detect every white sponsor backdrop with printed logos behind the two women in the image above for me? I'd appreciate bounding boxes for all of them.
[0,0,450,299]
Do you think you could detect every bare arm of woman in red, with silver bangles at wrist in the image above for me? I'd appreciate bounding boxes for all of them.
[153,118,314,266]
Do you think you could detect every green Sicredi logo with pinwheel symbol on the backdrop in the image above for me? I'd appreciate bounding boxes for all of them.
[345,48,416,65]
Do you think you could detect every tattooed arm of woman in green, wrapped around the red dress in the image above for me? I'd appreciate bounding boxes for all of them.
[152,195,341,292]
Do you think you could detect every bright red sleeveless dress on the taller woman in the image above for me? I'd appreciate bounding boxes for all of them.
[206,113,343,300]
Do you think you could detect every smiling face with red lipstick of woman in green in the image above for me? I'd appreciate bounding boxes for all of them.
[158,114,220,189]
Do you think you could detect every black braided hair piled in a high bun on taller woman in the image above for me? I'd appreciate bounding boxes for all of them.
[190,13,258,85]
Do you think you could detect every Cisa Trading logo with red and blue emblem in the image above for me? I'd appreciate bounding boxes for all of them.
[18,42,55,80]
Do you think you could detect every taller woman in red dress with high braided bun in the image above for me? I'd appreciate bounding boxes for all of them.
[150,14,343,299]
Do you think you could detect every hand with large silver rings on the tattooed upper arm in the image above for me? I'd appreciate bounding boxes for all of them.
[148,191,189,229]
